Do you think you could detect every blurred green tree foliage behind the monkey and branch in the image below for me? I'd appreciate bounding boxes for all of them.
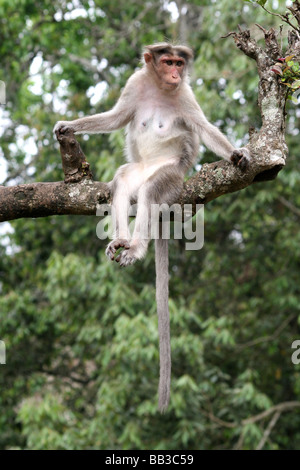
[0,0,300,450]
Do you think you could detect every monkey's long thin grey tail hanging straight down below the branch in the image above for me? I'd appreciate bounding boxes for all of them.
[155,238,171,413]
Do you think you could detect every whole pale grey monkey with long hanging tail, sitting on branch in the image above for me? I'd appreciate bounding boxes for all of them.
[54,42,250,413]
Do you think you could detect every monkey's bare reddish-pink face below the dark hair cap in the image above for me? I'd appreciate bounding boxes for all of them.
[145,54,185,90]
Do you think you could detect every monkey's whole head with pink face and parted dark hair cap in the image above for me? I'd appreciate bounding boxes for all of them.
[144,42,193,90]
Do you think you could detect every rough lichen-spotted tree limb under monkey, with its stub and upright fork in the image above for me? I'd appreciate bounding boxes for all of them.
[0,5,300,222]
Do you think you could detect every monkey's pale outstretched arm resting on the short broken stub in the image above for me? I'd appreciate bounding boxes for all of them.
[53,78,136,134]
